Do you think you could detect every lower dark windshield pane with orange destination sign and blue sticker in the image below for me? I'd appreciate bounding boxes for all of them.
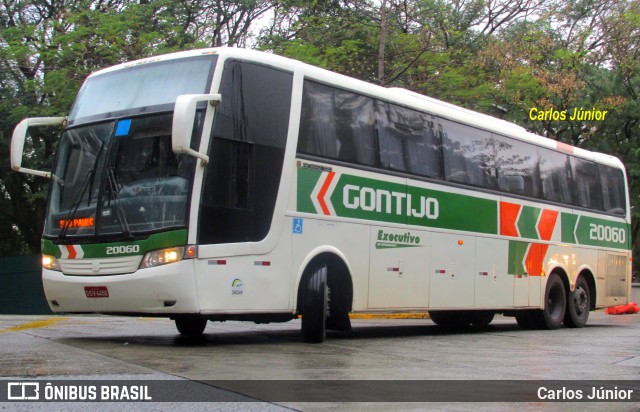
[44,113,202,240]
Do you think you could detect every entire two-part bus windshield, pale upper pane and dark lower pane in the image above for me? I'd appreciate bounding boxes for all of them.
[44,55,217,241]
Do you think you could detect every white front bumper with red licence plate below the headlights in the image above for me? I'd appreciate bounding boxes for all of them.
[42,260,200,316]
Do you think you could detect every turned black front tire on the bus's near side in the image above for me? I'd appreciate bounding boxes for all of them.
[302,264,329,343]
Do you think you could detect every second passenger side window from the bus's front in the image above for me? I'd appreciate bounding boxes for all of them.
[376,101,442,177]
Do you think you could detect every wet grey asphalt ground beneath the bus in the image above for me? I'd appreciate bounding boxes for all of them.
[0,311,640,411]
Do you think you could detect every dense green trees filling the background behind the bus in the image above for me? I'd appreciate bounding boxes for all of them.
[0,0,640,264]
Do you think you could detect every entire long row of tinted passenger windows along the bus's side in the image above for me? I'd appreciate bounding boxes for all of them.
[298,80,626,216]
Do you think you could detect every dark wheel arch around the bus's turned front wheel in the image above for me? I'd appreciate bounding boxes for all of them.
[295,246,353,314]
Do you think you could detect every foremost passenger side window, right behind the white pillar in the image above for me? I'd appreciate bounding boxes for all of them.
[298,81,376,166]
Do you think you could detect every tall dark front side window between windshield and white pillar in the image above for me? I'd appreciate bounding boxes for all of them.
[200,61,292,244]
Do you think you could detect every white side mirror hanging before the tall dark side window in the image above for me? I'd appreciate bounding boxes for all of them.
[171,94,222,162]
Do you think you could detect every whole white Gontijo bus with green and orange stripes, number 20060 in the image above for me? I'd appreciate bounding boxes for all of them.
[11,48,632,342]
